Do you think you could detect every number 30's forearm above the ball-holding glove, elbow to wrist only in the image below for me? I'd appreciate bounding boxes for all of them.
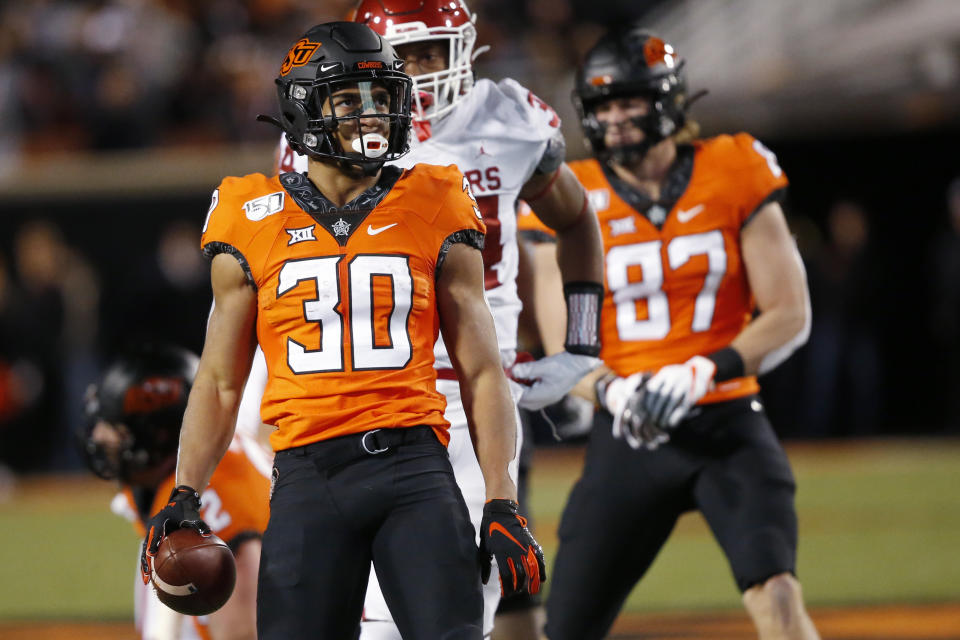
[177,374,240,493]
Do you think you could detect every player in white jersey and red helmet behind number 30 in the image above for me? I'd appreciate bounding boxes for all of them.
[262,0,603,640]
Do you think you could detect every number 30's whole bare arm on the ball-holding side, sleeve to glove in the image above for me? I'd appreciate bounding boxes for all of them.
[177,254,257,490]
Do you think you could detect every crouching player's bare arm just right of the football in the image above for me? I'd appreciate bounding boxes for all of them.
[207,538,260,640]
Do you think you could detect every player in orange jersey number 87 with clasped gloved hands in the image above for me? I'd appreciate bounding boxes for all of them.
[532,25,818,640]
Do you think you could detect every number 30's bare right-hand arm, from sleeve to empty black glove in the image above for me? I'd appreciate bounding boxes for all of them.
[437,244,517,501]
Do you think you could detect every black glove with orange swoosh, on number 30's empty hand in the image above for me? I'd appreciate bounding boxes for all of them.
[480,498,547,598]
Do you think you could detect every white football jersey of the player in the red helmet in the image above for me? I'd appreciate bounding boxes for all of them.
[279,78,560,368]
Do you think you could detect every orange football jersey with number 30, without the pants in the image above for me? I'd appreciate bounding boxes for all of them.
[201,165,484,450]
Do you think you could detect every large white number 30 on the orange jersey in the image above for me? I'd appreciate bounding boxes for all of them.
[277,255,413,374]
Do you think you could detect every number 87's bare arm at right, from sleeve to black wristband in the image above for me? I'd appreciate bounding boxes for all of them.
[730,202,810,375]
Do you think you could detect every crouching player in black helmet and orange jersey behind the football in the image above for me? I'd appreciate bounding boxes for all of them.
[80,345,270,640]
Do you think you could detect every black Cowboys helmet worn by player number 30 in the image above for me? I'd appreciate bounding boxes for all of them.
[258,22,412,175]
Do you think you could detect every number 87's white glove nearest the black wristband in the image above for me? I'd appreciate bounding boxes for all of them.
[643,356,717,429]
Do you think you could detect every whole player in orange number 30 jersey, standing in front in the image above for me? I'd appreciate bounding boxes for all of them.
[142,22,545,640]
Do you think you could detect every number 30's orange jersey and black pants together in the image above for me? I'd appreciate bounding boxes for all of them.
[202,165,484,639]
